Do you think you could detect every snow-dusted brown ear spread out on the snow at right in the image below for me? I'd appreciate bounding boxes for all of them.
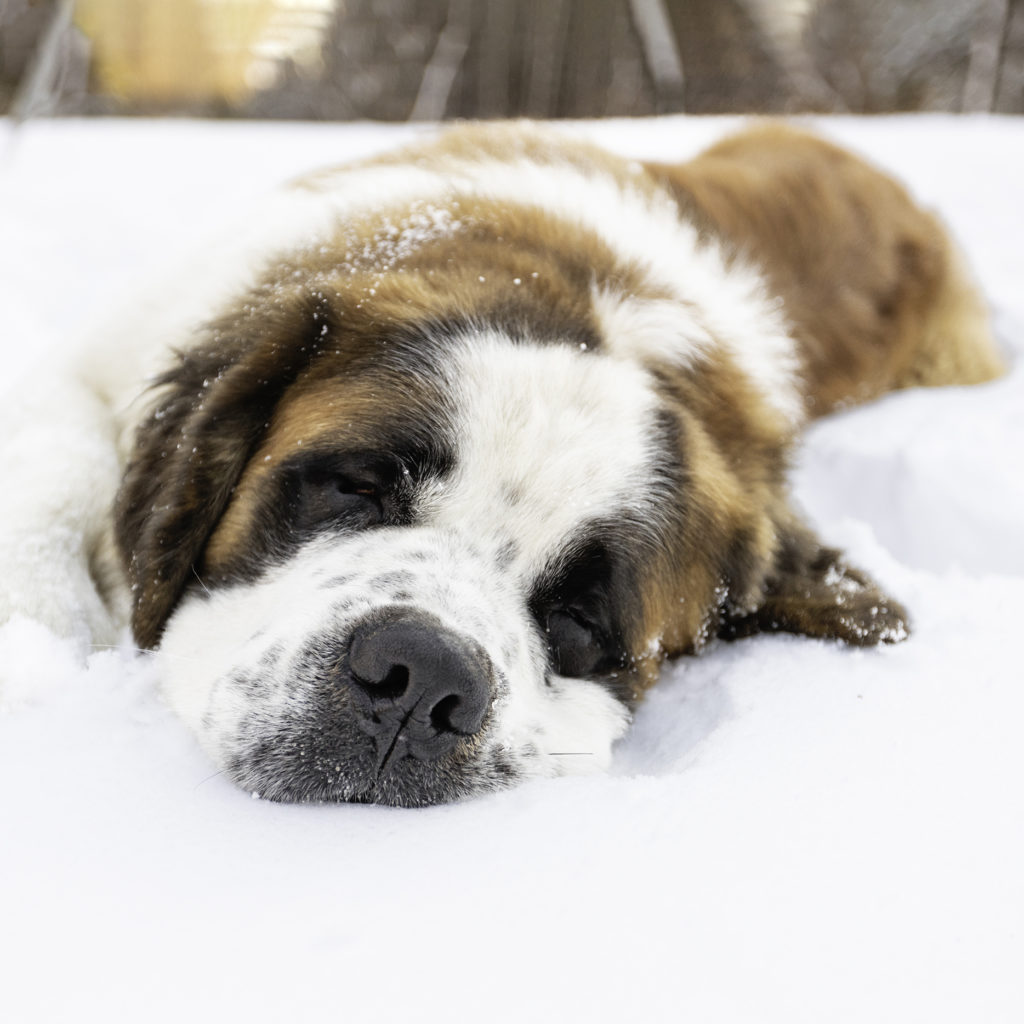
[719,522,909,647]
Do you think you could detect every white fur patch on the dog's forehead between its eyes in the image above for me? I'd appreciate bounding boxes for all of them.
[425,332,657,571]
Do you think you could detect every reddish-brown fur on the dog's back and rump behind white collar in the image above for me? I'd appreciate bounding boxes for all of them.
[648,124,1001,415]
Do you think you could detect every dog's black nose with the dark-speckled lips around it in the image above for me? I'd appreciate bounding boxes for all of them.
[217,608,519,807]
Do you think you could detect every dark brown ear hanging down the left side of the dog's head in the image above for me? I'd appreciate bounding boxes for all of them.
[115,291,337,647]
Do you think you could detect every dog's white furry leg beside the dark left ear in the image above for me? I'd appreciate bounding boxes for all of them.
[0,376,125,644]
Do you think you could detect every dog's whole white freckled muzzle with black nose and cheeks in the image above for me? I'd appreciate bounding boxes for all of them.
[161,527,626,807]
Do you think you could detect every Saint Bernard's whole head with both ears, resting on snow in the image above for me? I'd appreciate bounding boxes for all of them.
[118,188,902,805]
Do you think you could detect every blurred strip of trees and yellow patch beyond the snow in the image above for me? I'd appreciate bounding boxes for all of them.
[0,0,1024,121]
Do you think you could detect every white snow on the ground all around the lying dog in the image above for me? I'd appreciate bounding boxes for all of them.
[0,117,1024,1024]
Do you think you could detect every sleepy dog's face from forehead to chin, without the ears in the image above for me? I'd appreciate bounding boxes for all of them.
[153,332,680,804]
